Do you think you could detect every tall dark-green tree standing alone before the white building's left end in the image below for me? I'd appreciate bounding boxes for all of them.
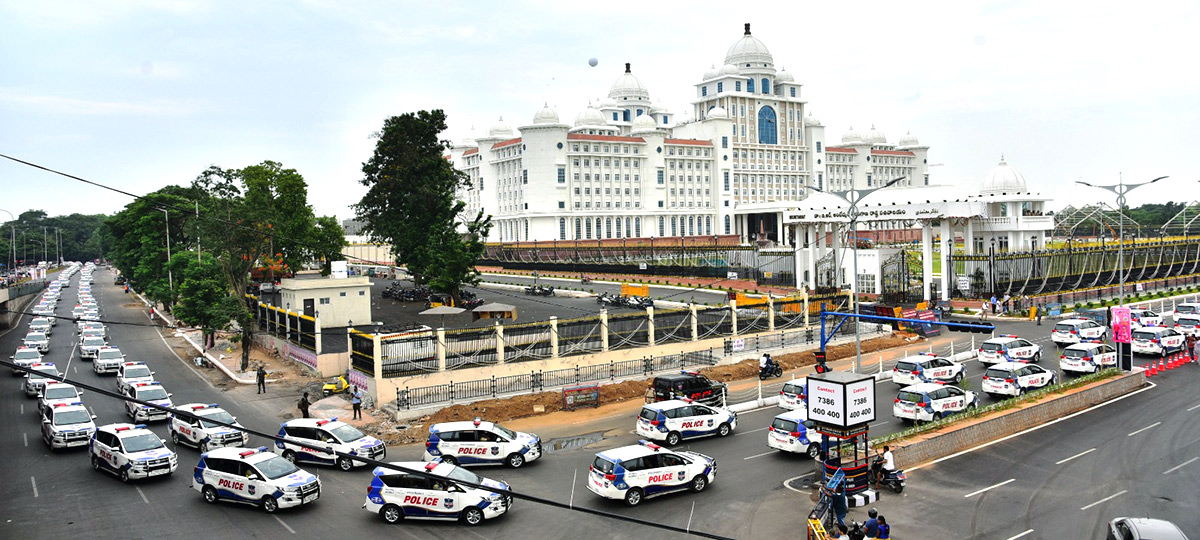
[354,110,491,298]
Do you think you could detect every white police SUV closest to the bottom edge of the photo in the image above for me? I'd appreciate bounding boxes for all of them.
[362,461,512,526]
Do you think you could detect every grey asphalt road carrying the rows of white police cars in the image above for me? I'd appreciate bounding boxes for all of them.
[0,271,1200,539]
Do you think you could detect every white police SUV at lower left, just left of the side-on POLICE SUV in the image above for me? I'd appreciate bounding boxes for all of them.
[88,424,179,482]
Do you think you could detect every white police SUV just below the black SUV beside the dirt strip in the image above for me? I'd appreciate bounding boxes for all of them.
[636,400,738,446]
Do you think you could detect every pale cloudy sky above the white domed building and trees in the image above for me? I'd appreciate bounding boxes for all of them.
[0,0,1200,223]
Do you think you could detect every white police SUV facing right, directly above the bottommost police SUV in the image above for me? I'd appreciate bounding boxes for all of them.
[424,418,541,468]
